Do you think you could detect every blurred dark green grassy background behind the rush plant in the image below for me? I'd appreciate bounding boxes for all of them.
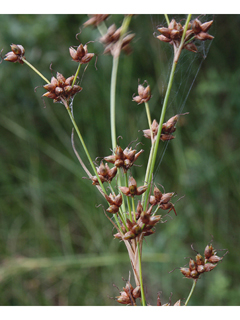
[0,14,240,306]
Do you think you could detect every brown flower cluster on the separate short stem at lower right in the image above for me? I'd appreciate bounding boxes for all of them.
[180,245,228,280]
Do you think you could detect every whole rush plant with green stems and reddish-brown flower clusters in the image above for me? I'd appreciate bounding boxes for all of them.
[1,14,227,306]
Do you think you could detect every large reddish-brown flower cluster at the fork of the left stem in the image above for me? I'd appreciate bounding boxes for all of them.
[42,72,82,102]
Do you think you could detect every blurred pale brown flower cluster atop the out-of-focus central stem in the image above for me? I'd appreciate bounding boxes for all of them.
[100,24,135,56]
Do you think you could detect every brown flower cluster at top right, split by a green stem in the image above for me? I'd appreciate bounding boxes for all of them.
[157,19,214,52]
